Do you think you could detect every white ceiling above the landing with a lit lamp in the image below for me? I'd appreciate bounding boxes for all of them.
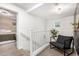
[15,3,75,19]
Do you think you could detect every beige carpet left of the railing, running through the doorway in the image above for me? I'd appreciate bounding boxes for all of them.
[0,43,30,56]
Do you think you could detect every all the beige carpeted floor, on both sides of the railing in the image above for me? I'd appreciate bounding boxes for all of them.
[0,43,76,56]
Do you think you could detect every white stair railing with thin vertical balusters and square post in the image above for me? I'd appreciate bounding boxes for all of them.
[30,31,50,55]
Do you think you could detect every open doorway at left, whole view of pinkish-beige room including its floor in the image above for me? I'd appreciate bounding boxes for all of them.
[0,7,17,56]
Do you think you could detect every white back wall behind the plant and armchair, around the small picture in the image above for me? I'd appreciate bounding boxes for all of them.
[47,16,74,36]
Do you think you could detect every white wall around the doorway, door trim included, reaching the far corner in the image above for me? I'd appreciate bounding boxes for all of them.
[0,4,45,50]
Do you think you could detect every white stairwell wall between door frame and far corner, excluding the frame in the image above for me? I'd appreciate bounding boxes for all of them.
[20,14,45,50]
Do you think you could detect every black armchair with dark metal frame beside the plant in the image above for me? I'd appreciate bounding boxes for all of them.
[50,35,74,56]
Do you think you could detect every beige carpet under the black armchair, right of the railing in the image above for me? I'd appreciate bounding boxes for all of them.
[37,46,76,56]
